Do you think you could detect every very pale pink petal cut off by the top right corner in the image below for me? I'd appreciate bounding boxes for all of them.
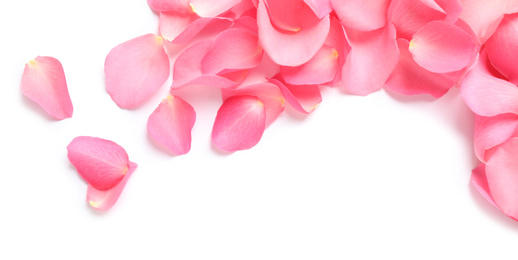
[460,0,518,43]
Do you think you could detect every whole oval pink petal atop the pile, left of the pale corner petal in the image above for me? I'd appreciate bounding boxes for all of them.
[409,21,476,73]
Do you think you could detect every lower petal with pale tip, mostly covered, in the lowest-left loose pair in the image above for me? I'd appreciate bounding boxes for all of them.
[86,162,137,211]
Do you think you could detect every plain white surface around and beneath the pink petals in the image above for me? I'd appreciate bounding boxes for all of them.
[0,0,518,260]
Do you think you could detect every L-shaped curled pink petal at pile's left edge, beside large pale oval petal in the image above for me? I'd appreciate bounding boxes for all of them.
[171,41,246,89]
